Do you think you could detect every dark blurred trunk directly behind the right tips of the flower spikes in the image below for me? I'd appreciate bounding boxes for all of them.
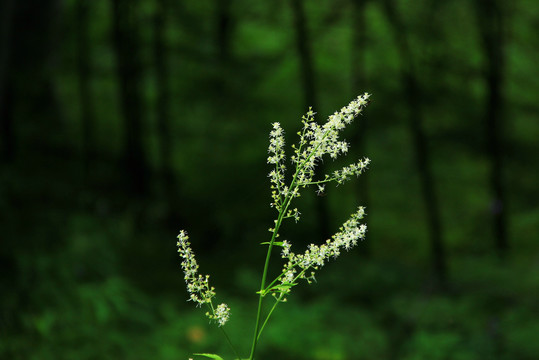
[351,0,370,256]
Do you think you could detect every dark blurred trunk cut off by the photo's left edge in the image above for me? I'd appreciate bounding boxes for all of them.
[0,0,15,162]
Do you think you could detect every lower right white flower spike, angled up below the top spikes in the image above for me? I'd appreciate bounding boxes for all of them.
[280,207,367,294]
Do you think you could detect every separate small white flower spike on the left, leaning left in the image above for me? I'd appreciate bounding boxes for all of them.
[177,230,230,326]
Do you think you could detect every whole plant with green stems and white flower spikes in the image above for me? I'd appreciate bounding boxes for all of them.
[177,93,370,360]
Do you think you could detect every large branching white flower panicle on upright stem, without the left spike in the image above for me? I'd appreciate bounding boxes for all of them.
[261,93,370,301]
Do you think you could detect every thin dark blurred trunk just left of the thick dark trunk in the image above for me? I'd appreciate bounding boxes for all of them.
[75,0,95,180]
